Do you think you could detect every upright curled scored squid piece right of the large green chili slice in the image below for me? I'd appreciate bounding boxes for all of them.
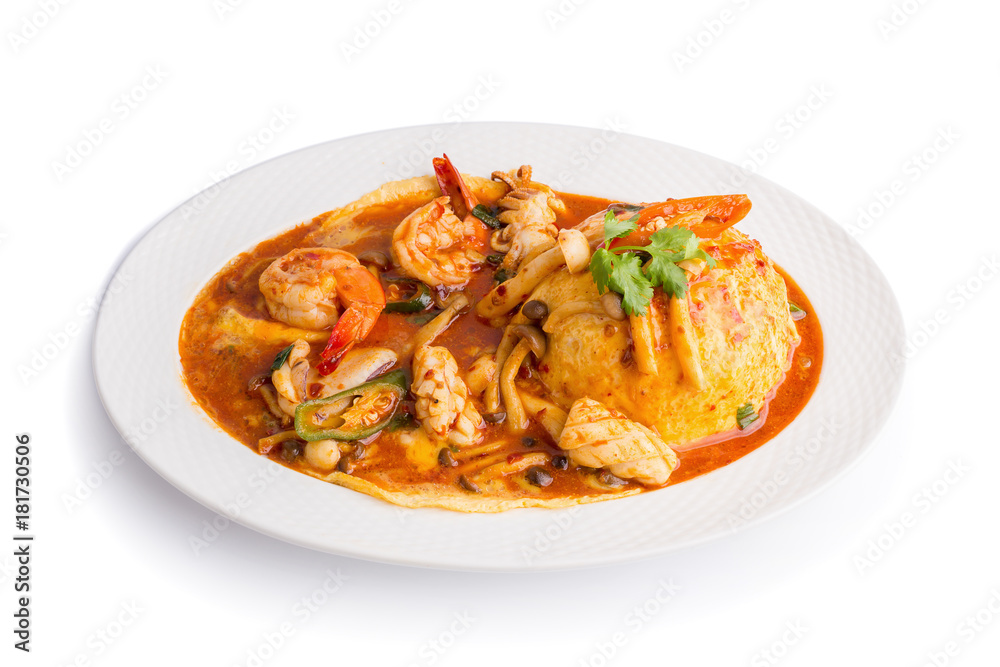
[410,345,486,446]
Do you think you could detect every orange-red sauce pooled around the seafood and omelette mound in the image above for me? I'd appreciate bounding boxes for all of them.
[179,190,823,498]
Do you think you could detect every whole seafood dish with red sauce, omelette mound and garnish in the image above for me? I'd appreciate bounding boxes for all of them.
[178,155,823,512]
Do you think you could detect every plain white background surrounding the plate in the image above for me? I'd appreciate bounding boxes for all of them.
[0,0,1000,667]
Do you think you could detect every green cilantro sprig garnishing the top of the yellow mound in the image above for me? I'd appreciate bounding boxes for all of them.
[590,211,715,316]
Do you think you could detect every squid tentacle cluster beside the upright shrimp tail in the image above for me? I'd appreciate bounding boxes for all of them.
[490,165,566,270]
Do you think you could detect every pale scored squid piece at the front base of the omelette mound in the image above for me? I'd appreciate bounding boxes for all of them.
[559,398,680,486]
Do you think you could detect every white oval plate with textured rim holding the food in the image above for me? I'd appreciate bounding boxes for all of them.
[94,123,903,570]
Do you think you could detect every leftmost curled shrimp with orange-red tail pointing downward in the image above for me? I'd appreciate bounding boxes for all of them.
[259,248,385,375]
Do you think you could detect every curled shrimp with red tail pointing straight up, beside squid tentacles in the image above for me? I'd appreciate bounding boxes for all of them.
[392,155,487,289]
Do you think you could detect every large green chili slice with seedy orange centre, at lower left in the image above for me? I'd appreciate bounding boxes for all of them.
[295,369,407,441]
